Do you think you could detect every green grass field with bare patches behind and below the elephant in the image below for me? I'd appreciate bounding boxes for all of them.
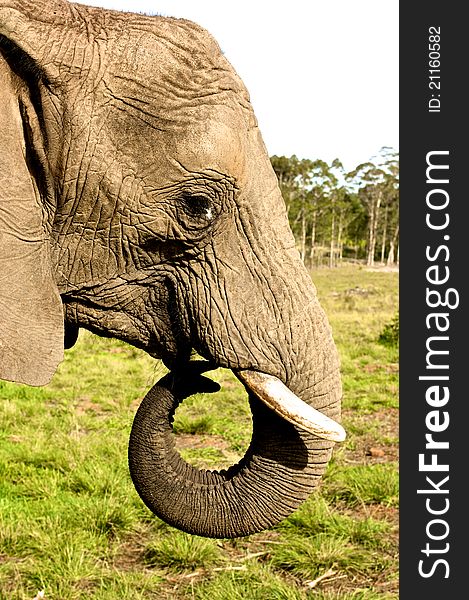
[0,266,398,600]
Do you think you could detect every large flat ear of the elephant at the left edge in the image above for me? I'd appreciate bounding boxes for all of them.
[0,53,64,385]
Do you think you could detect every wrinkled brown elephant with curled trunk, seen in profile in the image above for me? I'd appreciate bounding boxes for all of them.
[0,0,345,538]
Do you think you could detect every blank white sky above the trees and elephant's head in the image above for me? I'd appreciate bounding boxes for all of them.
[71,0,399,170]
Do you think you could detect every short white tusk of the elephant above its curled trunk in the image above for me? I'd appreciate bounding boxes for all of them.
[235,370,346,442]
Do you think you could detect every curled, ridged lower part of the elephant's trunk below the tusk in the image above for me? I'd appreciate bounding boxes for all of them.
[129,363,340,538]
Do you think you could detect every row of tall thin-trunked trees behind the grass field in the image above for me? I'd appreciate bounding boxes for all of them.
[271,147,399,267]
